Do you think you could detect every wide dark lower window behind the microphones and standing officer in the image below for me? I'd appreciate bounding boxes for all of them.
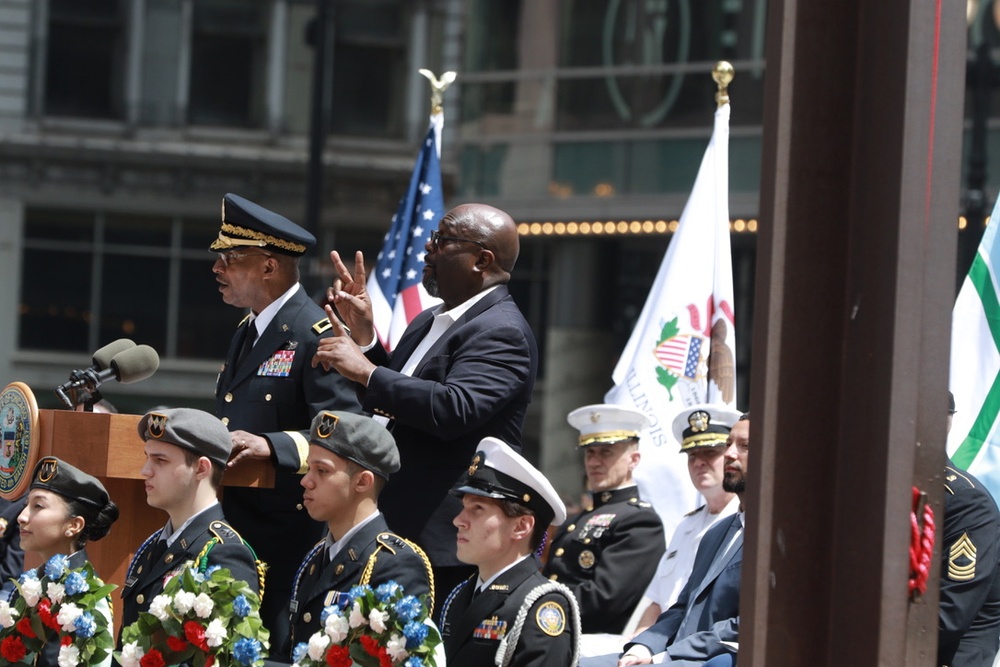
[18,209,236,359]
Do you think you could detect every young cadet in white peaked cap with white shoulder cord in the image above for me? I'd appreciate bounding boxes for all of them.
[441,438,580,667]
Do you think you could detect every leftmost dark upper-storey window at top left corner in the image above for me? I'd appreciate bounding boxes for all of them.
[44,0,126,119]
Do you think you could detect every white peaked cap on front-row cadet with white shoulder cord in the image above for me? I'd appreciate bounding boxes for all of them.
[451,438,566,526]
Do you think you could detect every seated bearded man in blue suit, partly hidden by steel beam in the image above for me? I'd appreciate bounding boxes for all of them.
[580,415,750,667]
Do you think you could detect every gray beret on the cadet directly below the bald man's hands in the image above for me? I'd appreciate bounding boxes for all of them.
[309,410,399,479]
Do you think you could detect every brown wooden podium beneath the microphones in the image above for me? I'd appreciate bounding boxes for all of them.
[25,410,274,637]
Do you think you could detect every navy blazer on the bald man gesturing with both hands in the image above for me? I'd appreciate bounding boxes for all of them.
[359,285,538,567]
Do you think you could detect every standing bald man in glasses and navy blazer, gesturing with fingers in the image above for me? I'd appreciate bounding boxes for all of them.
[313,204,538,590]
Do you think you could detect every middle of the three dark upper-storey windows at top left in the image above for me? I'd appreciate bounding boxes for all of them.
[188,0,269,127]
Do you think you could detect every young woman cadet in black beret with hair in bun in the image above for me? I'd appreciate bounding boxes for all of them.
[15,456,118,667]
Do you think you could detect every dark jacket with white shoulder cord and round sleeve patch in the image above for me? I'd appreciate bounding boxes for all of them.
[441,556,580,667]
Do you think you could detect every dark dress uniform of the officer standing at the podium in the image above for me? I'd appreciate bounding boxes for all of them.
[215,287,360,625]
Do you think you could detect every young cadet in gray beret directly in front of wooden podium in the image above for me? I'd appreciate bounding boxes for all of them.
[122,408,264,627]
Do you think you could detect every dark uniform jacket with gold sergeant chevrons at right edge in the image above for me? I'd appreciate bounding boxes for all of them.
[938,461,1000,667]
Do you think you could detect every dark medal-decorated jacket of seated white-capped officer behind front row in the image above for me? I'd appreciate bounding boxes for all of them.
[543,486,666,633]
